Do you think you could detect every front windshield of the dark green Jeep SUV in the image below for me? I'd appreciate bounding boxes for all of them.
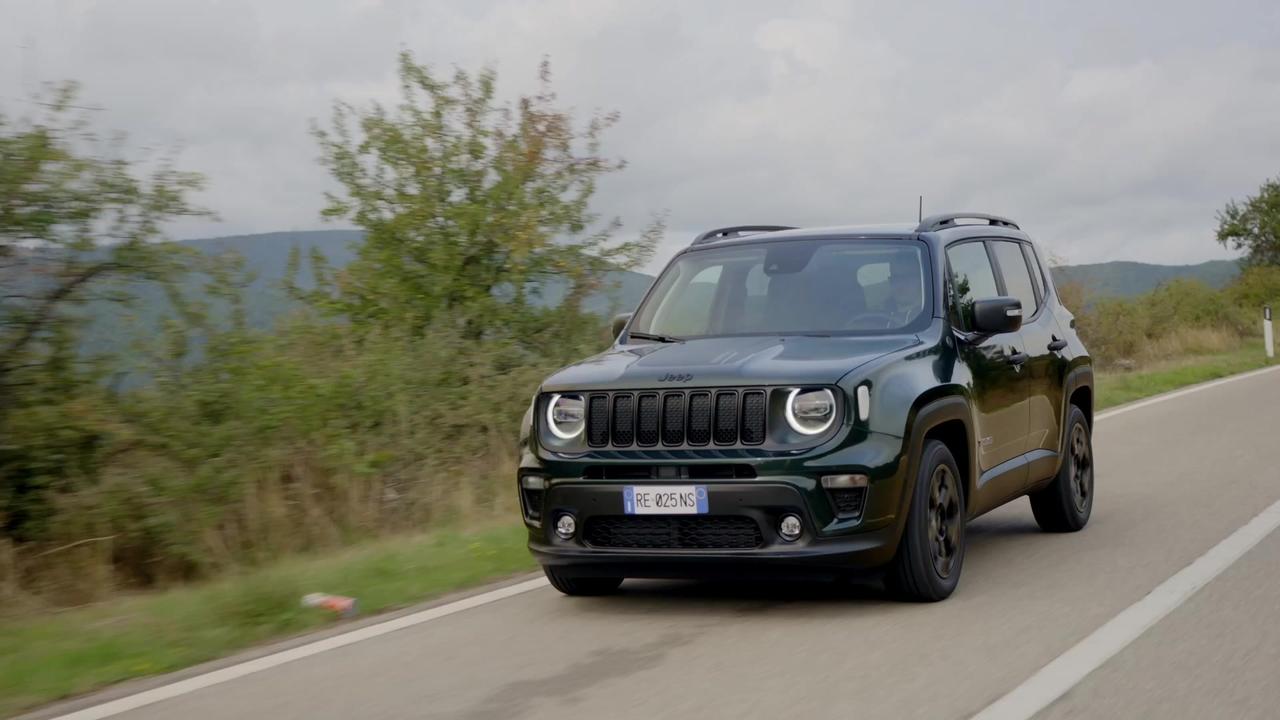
[631,240,931,338]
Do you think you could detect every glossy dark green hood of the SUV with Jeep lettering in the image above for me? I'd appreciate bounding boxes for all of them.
[543,336,920,392]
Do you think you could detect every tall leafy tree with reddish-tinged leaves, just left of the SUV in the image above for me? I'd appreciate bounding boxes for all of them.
[302,53,662,338]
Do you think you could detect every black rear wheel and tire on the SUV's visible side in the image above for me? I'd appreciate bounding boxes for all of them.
[1030,405,1093,533]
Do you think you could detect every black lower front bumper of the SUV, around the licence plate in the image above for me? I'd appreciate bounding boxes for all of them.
[529,478,900,578]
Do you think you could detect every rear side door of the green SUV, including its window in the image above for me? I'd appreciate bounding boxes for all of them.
[991,240,1068,483]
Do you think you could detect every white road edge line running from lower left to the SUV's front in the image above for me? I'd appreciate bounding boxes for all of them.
[48,578,547,720]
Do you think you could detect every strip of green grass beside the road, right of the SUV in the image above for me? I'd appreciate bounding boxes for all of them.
[1096,342,1275,410]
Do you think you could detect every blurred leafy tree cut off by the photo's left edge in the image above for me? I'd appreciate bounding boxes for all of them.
[0,83,202,539]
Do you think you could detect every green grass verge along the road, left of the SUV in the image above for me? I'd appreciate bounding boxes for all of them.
[0,523,535,716]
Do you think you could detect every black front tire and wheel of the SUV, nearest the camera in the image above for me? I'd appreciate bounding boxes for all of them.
[884,439,965,602]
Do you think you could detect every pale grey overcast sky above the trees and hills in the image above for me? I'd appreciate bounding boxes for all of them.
[0,0,1280,269]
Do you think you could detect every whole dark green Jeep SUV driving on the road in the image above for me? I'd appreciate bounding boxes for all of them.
[517,213,1093,601]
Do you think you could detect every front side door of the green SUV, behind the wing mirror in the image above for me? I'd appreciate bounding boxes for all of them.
[947,240,1028,499]
